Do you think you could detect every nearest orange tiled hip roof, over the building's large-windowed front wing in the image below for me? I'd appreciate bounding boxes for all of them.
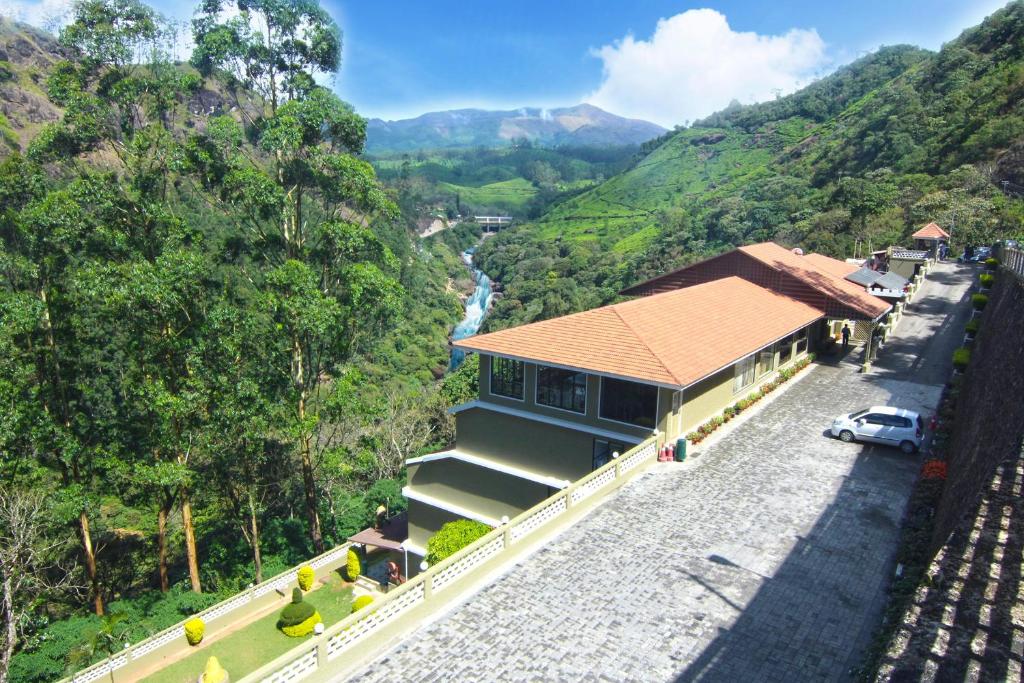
[454,276,822,387]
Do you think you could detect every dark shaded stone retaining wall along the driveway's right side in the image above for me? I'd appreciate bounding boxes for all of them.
[932,268,1024,548]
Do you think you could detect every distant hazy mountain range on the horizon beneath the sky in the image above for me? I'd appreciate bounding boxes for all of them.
[367,104,666,154]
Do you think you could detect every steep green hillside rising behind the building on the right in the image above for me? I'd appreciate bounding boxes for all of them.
[478,1,1024,329]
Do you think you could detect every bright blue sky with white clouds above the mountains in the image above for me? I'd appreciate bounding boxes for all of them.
[0,0,1005,127]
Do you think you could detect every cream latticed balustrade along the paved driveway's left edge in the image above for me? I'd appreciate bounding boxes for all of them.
[239,437,657,683]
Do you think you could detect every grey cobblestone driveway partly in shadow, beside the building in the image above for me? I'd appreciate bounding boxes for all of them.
[342,265,970,681]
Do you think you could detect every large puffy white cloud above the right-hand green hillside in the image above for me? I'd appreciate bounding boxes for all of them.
[587,9,829,128]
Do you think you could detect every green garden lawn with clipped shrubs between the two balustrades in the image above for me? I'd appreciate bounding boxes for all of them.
[142,573,352,683]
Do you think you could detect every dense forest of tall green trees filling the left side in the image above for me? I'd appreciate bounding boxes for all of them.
[0,0,475,681]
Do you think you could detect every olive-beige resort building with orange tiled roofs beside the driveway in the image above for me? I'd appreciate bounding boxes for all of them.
[403,243,891,556]
